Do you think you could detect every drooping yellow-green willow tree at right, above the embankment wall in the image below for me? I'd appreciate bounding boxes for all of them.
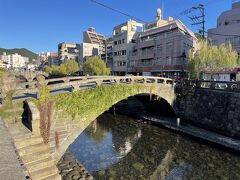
[188,40,238,79]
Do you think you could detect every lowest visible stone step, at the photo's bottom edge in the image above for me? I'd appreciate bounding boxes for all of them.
[30,166,58,180]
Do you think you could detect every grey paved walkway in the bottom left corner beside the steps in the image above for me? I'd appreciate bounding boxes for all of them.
[0,117,26,180]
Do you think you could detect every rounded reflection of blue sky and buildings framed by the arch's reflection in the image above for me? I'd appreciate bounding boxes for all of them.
[69,114,141,172]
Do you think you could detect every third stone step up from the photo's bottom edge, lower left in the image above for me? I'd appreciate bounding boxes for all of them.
[21,150,49,164]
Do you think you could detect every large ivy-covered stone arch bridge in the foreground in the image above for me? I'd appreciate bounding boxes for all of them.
[20,76,176,162]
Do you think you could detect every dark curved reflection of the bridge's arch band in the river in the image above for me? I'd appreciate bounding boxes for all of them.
[89,114,178,179]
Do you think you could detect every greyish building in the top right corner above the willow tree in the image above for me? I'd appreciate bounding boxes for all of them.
[208,1,240,53]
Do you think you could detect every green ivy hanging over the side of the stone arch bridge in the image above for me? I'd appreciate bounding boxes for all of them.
[52,84,155,120]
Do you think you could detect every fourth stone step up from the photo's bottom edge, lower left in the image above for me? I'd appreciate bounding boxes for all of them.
[18,142,48,156]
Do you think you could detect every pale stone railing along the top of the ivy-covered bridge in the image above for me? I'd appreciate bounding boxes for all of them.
[14,76,174,96]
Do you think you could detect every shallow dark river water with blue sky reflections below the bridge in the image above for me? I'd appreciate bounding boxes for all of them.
[69,113,240,180]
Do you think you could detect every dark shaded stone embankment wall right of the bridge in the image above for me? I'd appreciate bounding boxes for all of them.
[177,89,240,139]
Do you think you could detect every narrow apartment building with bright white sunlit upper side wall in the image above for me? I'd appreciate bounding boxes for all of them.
[112,20,143,75]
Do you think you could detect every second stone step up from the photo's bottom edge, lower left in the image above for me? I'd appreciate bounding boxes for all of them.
[25,156,55,173]
